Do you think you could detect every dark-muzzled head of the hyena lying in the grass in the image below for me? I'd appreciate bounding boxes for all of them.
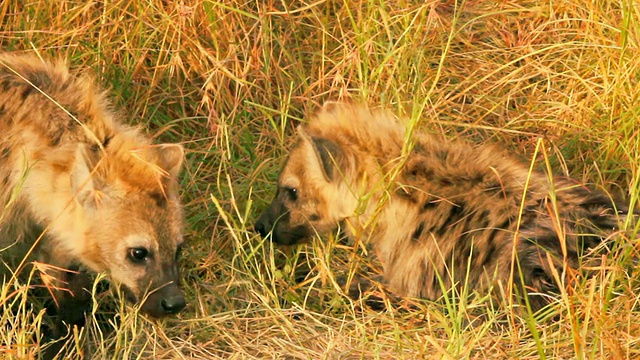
[255,122,354,245]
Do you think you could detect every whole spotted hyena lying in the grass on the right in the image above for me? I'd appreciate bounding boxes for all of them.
[255,103,627,309]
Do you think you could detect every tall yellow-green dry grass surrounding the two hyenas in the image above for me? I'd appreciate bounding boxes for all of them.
[0,0,640,359]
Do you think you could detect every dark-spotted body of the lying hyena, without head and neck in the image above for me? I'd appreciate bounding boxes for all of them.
[388,136,627,308]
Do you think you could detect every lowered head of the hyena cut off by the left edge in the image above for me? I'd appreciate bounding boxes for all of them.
[71,130,186,317]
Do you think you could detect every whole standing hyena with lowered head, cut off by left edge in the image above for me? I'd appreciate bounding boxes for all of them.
[0,54,185,334]
